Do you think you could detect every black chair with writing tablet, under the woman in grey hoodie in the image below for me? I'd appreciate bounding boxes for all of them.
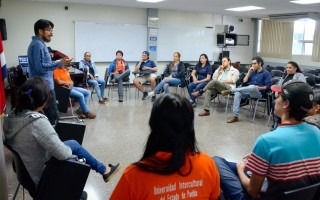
[3,142,91,200]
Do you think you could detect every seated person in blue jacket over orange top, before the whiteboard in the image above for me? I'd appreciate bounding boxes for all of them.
[109,50,130,102]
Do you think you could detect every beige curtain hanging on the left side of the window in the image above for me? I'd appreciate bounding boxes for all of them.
[260,20,294,59]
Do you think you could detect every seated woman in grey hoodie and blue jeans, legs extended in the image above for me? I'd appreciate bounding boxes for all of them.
[3,77,120,188]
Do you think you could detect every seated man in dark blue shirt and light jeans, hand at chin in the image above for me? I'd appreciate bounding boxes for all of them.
[221,57,271,123]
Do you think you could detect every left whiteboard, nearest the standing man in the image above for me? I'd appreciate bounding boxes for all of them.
[74,21,147,62]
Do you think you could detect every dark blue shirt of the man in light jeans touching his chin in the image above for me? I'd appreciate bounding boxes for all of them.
[248,68,272,96]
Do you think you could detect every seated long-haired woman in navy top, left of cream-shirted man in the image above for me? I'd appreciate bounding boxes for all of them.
[188,54,212,107]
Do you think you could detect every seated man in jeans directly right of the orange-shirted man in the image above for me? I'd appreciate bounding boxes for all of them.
[79,52,108,104]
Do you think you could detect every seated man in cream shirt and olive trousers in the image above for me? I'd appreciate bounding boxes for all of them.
[192,57,239,116]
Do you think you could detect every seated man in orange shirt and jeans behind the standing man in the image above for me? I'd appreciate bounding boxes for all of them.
[53,66,96,119]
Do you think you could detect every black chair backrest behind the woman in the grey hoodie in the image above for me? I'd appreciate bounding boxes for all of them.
[3,142,36,198]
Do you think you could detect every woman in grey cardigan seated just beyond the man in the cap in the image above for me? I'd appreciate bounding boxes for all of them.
[272,61,307,129]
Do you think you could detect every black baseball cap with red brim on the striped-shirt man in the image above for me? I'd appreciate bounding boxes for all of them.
[271,81,314,112]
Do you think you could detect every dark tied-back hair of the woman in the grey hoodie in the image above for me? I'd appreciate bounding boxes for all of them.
[15,77,50,114]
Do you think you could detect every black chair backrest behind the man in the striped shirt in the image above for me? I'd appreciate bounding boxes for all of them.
[281,183,320,200]
